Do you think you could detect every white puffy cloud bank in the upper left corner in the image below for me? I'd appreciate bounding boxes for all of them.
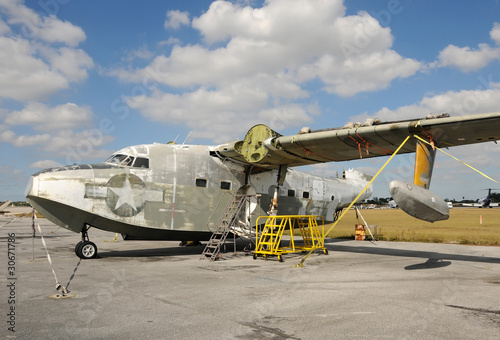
[0,1,94,101]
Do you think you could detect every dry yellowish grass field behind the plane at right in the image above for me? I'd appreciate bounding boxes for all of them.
[325,208,500,246]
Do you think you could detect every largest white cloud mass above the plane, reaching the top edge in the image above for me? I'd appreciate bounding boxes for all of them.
[108,0,422,138]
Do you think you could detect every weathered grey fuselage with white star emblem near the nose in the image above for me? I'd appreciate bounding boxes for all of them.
[26,144,371,241]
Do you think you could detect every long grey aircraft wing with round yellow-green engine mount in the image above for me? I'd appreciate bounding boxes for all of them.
[215,112,500,169]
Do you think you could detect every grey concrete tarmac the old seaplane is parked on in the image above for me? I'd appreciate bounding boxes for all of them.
[0,216,500,339]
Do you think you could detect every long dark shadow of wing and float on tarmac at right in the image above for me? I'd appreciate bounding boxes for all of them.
[327,242,500,270]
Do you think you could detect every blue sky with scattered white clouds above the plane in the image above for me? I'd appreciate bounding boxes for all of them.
[0,0,500,200]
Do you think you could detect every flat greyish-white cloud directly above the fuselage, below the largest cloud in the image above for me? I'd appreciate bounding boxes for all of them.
[128,83,310,142]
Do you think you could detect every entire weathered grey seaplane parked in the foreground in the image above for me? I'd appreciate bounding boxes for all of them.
[26,113,500,259]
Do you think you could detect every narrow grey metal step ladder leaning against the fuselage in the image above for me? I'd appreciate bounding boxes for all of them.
[200,194,251,261]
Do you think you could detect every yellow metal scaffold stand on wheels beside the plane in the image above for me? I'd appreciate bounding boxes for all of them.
[253,215,328,262]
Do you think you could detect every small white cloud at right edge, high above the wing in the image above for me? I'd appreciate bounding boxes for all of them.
[437,23,500,72]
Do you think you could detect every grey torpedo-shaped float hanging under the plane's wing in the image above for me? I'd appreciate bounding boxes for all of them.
[389,181,450,222]
